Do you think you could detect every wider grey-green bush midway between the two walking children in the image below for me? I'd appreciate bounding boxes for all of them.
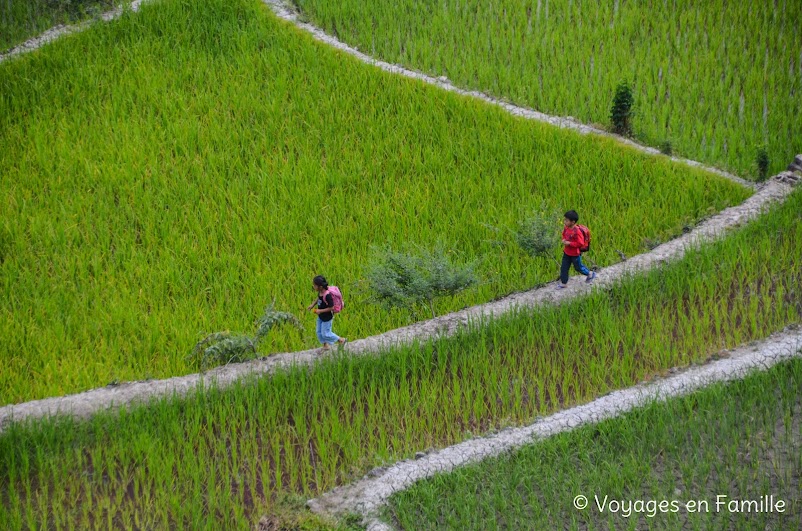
[365,245,479,317]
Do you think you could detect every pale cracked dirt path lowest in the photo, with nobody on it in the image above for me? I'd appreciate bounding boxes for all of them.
[307,326,802,529]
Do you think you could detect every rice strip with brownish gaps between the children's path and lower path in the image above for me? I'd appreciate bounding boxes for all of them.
[0,186,802,529]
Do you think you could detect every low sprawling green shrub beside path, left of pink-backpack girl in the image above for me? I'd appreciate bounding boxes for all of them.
[188,301,303,371]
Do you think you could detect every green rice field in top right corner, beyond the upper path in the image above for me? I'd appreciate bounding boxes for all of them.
[294,0,802,178]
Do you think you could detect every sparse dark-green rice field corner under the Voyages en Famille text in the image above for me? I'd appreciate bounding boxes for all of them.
[386,359,802,530]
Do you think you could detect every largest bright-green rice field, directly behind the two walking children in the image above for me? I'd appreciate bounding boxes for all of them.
[0,0,750,404]
